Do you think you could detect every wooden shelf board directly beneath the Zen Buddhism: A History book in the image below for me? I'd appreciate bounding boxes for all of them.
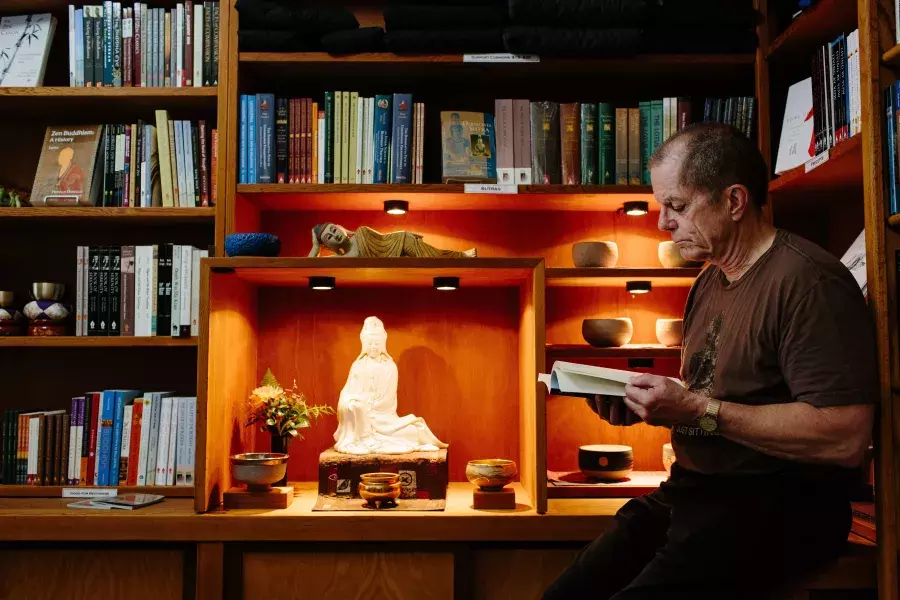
[0,207,216,224]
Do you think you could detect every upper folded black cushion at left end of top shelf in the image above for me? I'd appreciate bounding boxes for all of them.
[234,0,359,36]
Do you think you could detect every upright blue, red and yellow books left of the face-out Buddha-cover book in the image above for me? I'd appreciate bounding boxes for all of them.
[238,92,425,183]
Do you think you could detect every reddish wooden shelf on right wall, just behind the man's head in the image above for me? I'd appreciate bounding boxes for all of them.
[769,135,863,194]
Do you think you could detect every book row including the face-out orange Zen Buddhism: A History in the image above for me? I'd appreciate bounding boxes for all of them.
[31,115,218,208]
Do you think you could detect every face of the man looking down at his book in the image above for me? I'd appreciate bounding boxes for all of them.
[650,153,733,261]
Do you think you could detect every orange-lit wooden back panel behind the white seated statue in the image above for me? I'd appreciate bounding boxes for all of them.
[253,287,519,481]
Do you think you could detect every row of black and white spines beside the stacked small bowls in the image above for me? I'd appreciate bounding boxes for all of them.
[75,244,209,337]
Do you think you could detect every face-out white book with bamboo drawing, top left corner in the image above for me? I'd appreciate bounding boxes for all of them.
[0,11,55,87]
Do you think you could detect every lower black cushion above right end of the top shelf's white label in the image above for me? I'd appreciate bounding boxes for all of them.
[503,27,641,56]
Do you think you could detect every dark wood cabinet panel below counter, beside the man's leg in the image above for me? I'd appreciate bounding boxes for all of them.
[471,548,578,600]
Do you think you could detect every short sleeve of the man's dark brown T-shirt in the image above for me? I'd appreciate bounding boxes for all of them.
[779,276,879,407]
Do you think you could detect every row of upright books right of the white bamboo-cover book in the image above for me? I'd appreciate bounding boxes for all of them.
[69,0,219,87]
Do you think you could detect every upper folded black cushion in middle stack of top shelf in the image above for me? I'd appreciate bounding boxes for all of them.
[384,5,509,31]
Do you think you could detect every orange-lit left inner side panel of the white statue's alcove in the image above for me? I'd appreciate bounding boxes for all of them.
[195,272,259,512]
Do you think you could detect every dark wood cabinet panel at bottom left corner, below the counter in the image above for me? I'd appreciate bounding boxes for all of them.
[0,548,184,600]
